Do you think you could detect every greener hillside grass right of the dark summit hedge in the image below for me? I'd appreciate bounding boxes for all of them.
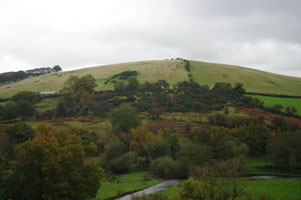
[190,61,301,95]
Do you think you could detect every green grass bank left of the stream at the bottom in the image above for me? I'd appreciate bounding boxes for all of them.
[96,172,161,200]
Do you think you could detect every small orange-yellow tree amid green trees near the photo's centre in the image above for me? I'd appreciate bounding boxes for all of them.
[130,127,153,154]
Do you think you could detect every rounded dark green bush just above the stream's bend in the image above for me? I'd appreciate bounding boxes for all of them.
[150,156,183,179]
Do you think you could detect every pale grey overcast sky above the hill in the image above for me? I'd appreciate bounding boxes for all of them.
[0,0,301,77]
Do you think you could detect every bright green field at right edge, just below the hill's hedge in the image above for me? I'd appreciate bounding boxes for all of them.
[248,94,301,115]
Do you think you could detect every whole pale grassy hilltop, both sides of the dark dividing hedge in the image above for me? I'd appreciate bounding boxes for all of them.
[0,60,301,98]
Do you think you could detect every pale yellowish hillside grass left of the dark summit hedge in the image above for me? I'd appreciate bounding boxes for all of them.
[0,60,188,98]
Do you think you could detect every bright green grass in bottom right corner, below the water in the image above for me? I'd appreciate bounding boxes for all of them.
[245,179,301,200]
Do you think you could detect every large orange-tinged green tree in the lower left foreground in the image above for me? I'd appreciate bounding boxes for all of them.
[16,125,102,200]
